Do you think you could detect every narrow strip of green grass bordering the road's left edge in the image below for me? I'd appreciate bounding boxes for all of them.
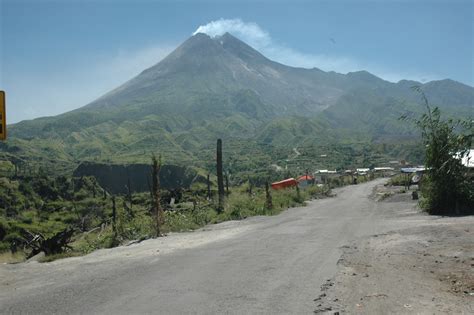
[39,186,330,262]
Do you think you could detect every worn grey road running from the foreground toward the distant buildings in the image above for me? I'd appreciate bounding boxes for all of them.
[0,180,436,314]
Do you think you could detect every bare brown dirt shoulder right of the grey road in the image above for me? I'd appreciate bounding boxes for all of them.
[315,196,474,314]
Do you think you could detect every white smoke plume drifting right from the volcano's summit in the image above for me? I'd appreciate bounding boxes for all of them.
[193,18,436,82]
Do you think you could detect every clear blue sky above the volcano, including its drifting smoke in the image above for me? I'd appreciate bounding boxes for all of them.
[0,0,474,123]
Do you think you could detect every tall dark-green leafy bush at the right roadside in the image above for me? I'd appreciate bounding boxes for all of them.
[402,87,474,214]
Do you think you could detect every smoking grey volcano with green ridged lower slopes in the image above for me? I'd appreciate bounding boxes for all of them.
[4,33,474,173]
